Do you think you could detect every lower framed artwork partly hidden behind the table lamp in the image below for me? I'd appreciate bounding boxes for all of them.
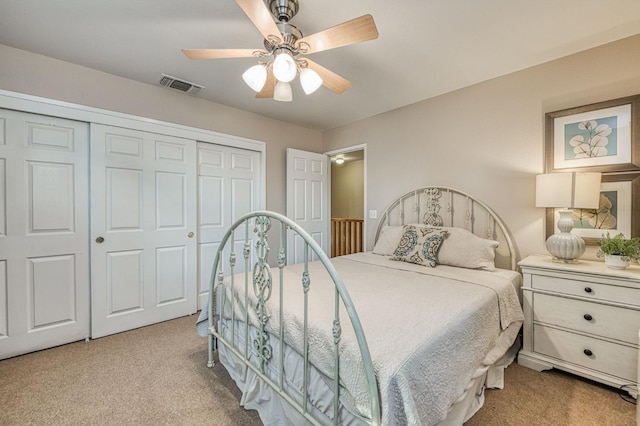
[546,172,640,245]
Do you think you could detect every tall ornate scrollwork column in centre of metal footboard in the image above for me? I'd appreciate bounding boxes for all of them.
[253,216,273,373]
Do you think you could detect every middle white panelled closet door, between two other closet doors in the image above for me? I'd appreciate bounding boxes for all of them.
[91,124,197,338]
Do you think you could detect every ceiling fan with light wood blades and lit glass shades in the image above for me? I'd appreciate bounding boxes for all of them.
[182,0,378,101]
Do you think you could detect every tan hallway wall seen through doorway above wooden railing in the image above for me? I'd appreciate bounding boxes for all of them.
[331,160,364,219]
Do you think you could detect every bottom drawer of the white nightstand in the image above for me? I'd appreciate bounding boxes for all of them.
[533,324,638,383]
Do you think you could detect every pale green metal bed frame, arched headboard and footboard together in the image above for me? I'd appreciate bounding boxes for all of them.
[207,187,517,425]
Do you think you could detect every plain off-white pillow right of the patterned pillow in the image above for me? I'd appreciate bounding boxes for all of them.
[423,225,499,271]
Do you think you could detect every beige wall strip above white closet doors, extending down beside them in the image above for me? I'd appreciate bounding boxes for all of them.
[0,45,322,213]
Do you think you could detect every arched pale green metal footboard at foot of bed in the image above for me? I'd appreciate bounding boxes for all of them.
[207,211,381,425]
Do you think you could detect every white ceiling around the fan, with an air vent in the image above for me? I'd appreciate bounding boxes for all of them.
[0,0,640,130]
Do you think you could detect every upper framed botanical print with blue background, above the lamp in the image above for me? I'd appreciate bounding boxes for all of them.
[545,95,640,173]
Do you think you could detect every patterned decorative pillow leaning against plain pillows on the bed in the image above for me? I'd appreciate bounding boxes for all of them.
[391,225,447,268]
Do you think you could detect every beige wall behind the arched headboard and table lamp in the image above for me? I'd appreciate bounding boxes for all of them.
[323,36,640,257]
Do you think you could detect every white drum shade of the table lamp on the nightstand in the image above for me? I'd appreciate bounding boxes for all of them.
[536,172,602,209]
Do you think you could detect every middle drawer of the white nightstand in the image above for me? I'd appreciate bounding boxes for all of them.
[533,293,640,344]
